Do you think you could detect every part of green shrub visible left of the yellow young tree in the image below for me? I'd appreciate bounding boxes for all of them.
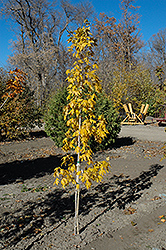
[44,88,67,147]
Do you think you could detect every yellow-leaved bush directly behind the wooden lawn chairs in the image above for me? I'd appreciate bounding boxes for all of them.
[111,64,154,113]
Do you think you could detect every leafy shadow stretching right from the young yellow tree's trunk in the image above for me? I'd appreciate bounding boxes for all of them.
[80,164,164,233]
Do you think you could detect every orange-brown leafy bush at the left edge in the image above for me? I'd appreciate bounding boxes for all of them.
[0,68,41,140]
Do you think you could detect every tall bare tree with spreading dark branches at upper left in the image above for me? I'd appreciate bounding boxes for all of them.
[1,0,92,105]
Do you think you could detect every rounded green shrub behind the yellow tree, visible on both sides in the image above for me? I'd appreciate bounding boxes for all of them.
[44,88,121,151]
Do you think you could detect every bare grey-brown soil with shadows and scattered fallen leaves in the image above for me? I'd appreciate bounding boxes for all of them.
[0,126,166,250]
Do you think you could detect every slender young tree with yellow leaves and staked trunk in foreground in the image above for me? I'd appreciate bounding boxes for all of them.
[54,20,110,235]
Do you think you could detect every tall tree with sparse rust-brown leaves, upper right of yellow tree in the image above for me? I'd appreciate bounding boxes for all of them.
[95,0,143,93]
